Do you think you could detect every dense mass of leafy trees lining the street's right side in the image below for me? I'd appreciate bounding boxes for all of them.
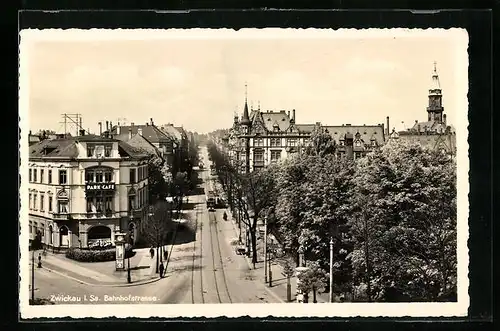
[208,132,457,302]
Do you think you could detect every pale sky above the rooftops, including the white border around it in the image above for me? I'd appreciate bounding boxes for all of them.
[20,29,468,133]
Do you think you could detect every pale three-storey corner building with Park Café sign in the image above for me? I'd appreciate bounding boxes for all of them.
[28,135,148,249]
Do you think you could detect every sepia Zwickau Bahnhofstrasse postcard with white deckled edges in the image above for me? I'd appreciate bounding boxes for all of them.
[19,29,469,319]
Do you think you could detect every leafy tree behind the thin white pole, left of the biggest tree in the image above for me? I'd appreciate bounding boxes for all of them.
[276,155,354,291]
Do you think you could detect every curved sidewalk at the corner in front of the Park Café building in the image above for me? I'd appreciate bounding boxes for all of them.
[35,249,160,287]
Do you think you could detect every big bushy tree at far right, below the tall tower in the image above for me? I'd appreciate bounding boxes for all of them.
[351,142,456,301]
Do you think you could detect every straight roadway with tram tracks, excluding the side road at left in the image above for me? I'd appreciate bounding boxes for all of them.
[154,147,279,304]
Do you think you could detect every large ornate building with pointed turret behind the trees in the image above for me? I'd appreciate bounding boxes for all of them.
[221,91,386,173]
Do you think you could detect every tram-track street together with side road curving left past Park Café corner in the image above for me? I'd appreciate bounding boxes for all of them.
[30,147,279,304]
